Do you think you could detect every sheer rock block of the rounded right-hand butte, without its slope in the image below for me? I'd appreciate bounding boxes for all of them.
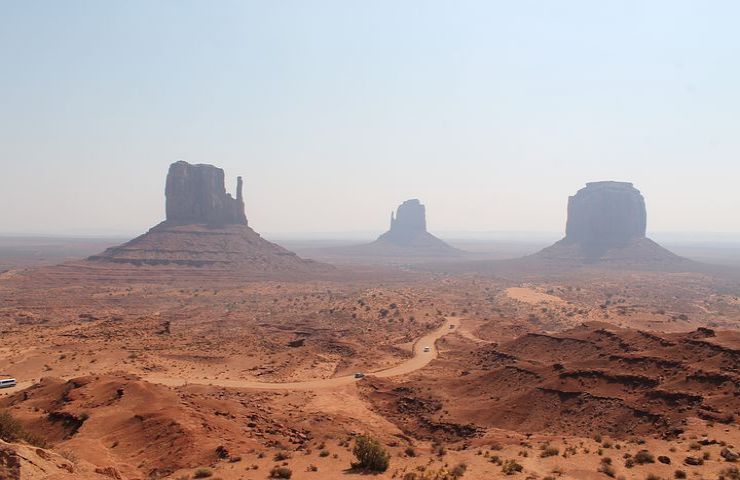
[565,182,647,246]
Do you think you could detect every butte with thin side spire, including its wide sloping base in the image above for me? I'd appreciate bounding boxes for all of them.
[89,161,327,274]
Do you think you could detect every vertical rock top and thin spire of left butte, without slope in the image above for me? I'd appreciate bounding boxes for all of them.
[165,160,247,225]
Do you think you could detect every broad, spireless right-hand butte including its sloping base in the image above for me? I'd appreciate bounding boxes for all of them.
[535,181,683,263]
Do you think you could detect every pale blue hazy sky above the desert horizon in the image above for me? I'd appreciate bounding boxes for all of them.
[0,0,740,234]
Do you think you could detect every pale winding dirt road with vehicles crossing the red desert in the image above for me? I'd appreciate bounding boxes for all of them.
[144,317,460,390]
